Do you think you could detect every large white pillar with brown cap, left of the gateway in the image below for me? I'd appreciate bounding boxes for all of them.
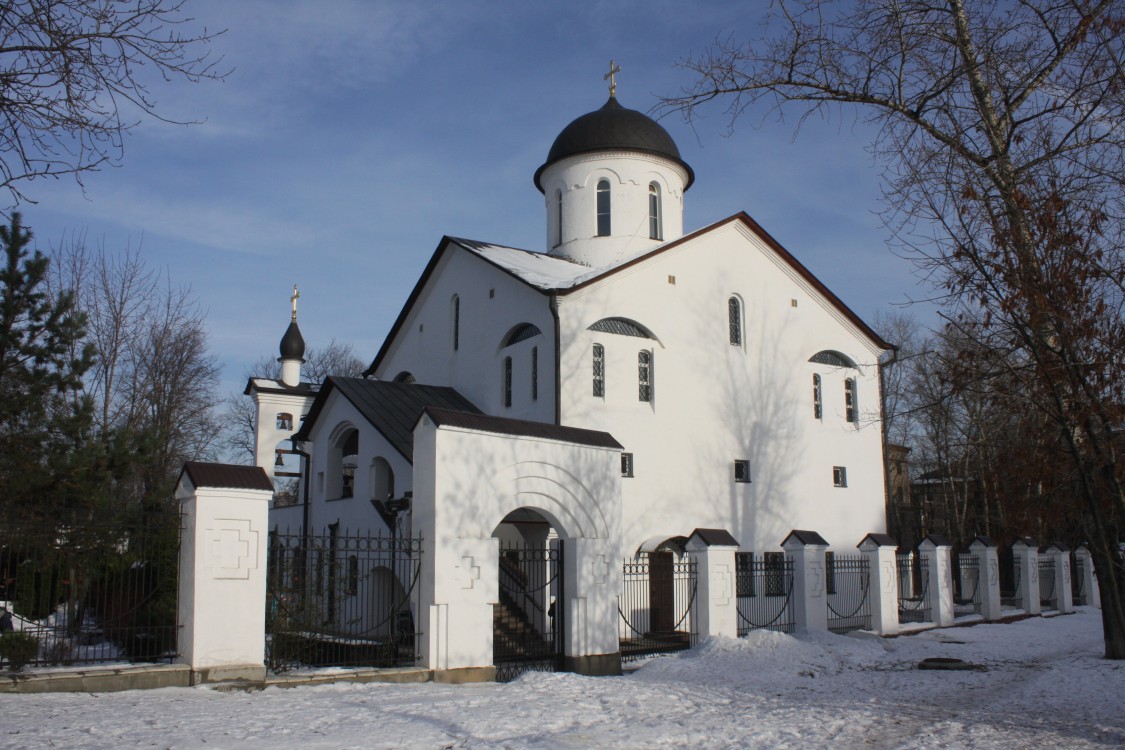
[176,462,273,683]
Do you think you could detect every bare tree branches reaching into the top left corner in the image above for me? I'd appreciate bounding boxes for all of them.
[0,0,225,205]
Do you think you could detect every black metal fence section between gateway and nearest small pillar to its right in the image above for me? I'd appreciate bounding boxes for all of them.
[618,552,699,661]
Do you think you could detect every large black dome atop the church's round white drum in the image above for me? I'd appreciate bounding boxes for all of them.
[536,96,695,192]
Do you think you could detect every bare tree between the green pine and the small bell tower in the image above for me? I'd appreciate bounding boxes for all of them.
[51,236,221,499]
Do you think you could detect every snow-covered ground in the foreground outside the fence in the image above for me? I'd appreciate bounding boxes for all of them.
[0,608,1125,750]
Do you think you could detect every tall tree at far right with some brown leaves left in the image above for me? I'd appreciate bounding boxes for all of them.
[666,0,1125,659]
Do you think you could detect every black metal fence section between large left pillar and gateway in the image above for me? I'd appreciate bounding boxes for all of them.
[266,526,422,671]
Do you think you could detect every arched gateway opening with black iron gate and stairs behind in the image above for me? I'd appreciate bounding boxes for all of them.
[493,508,564,683]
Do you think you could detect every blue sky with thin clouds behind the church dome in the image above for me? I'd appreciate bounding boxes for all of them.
[21,0,925,394]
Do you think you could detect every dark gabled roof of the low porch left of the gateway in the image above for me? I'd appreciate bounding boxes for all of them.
[294,376,480,463]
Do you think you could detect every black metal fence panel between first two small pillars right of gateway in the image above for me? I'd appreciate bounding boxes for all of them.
[735,552,797,638]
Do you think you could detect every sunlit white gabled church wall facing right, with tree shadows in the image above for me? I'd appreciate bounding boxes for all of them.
[559,222,885,552]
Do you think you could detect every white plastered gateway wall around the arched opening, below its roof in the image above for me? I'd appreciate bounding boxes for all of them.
[413,417,621,669]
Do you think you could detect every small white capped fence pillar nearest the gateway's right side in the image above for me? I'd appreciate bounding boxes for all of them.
[686,528,738,638]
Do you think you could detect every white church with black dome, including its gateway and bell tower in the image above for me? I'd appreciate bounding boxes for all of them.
[246,76,890,674]
